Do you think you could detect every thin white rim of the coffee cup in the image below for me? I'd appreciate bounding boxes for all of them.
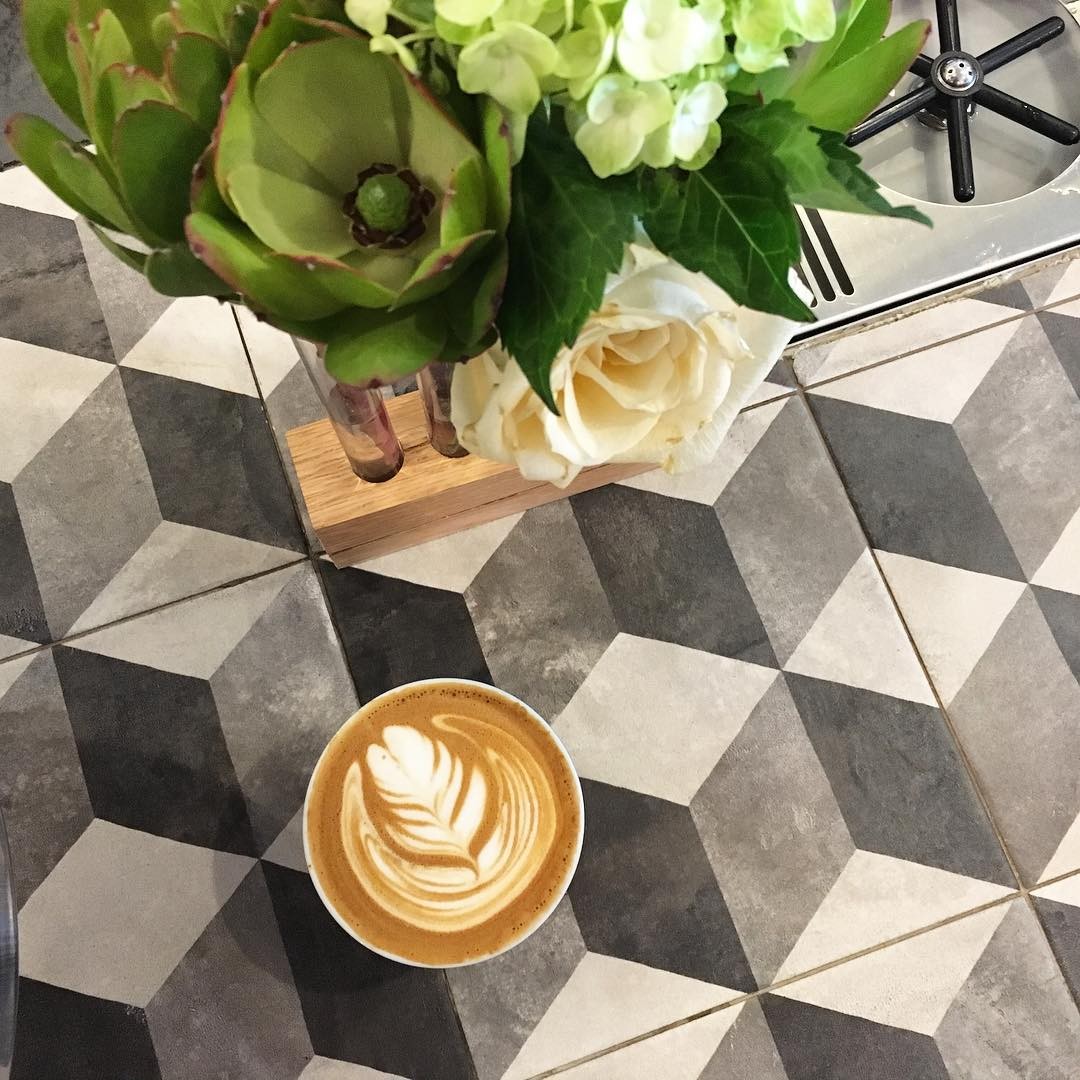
[301,676,585,970]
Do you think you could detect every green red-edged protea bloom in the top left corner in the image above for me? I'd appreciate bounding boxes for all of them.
[6,0,274,296]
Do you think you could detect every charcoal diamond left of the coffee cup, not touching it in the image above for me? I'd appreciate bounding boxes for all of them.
[55,646,257,855]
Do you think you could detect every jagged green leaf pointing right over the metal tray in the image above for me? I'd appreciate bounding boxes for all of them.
[725,100,931,225]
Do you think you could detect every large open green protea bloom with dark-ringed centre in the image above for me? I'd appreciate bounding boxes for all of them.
[186,27,511,384]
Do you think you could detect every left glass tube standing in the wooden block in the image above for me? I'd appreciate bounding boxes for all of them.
[293,338,405,484]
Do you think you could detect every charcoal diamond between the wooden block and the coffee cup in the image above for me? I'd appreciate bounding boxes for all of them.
[319,561,491,702]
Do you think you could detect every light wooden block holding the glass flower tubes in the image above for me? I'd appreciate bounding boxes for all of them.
[286,392,653,566]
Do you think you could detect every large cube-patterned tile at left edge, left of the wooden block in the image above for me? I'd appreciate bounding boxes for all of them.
[0,171,305,657]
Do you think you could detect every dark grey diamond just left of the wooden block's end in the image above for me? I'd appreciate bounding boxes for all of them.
[121,367,303,551]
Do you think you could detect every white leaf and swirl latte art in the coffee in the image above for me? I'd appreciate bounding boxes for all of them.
[341,713,556,932]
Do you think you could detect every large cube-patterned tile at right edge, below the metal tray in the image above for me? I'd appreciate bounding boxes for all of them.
[810,304,1080,886]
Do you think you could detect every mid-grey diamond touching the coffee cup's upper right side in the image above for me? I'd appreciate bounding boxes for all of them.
[465,501,618,718]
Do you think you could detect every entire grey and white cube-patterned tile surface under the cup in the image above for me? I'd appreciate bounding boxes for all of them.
[0,137,1080,1080]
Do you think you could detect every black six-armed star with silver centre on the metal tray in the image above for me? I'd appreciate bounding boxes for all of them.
[847,0,1080,202]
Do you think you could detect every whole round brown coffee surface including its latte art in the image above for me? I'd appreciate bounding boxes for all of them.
[305,681,582,967]
